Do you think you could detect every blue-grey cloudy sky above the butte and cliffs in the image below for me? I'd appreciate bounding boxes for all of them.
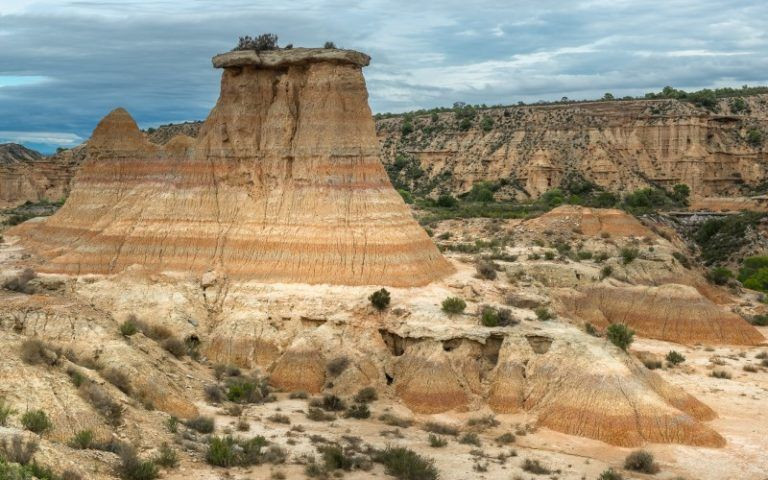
[0,0,768,151]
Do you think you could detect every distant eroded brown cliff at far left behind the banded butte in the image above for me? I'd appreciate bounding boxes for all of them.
[0,143,82,208]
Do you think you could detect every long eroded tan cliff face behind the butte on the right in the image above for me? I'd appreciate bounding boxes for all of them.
[376,95,768,199]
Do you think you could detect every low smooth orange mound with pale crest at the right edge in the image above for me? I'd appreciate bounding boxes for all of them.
[561,284,765,345]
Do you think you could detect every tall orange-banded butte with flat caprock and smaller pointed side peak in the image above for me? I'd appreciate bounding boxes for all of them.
[9,48,452,287]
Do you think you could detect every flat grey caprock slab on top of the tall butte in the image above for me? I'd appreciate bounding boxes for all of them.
[213,48,371,68]
